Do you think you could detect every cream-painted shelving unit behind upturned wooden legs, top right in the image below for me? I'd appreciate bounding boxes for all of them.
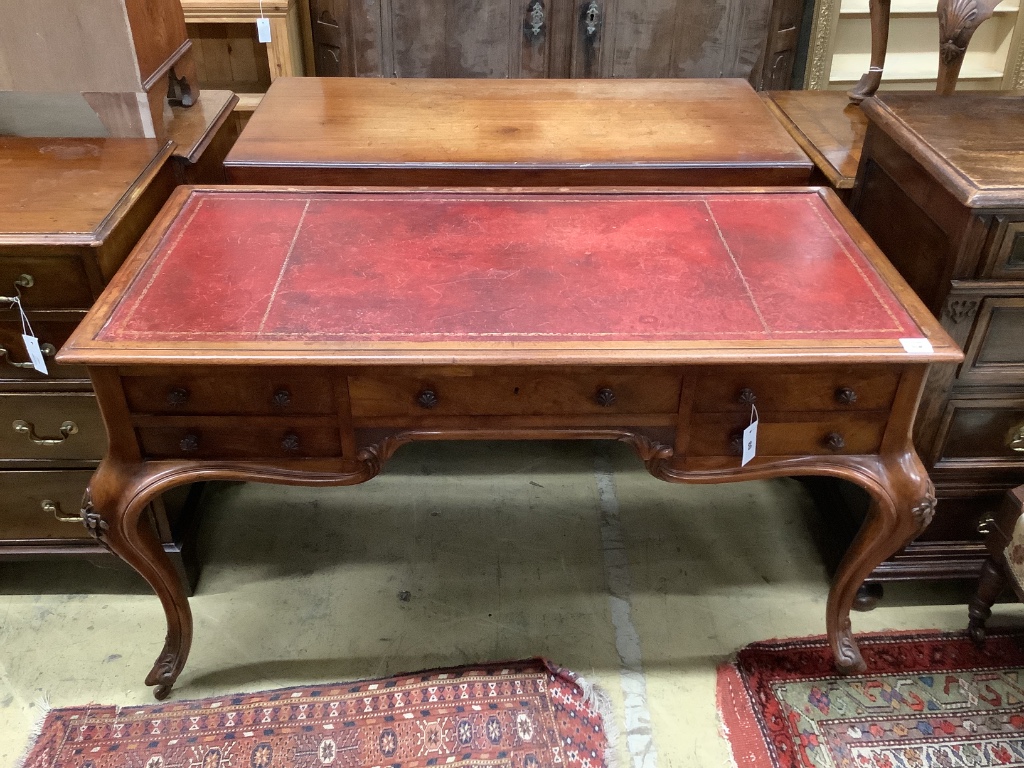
[804,0,1024,90]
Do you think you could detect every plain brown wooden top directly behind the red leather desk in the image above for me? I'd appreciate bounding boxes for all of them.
[225,78,811,181]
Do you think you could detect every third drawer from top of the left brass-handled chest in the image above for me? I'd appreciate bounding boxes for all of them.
[0,392,106,461]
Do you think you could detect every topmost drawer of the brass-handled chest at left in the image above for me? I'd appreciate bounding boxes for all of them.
[0,255,96,310]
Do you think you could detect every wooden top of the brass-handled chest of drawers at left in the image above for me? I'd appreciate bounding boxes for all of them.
[0,136,174,245]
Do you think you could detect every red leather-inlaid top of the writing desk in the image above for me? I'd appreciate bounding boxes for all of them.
[58,187,959,365]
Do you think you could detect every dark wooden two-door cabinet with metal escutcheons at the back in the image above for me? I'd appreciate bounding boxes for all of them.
[309,0,803,88]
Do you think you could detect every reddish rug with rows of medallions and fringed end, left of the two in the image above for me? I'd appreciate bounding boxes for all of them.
[25,659,612,768]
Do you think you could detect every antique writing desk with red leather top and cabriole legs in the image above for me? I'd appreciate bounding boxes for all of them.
[58,187,962,698]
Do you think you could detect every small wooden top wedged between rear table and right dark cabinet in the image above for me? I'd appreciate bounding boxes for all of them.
[763,91,867,189]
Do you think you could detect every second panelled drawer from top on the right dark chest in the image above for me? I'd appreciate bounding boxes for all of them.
[946,284,1024,385]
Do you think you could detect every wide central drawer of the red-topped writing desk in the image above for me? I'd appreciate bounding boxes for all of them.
[348,369,681,419]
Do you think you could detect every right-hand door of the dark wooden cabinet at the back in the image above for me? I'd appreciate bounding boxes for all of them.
[571,0,772,79]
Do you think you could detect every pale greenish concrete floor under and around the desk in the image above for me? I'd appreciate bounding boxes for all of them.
[0,442,999,768]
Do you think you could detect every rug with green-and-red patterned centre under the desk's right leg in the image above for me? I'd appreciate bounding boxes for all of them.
[718,633,1024,768]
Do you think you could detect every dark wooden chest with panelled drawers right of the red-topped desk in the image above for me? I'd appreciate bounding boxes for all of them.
[851,91,1024,580]
